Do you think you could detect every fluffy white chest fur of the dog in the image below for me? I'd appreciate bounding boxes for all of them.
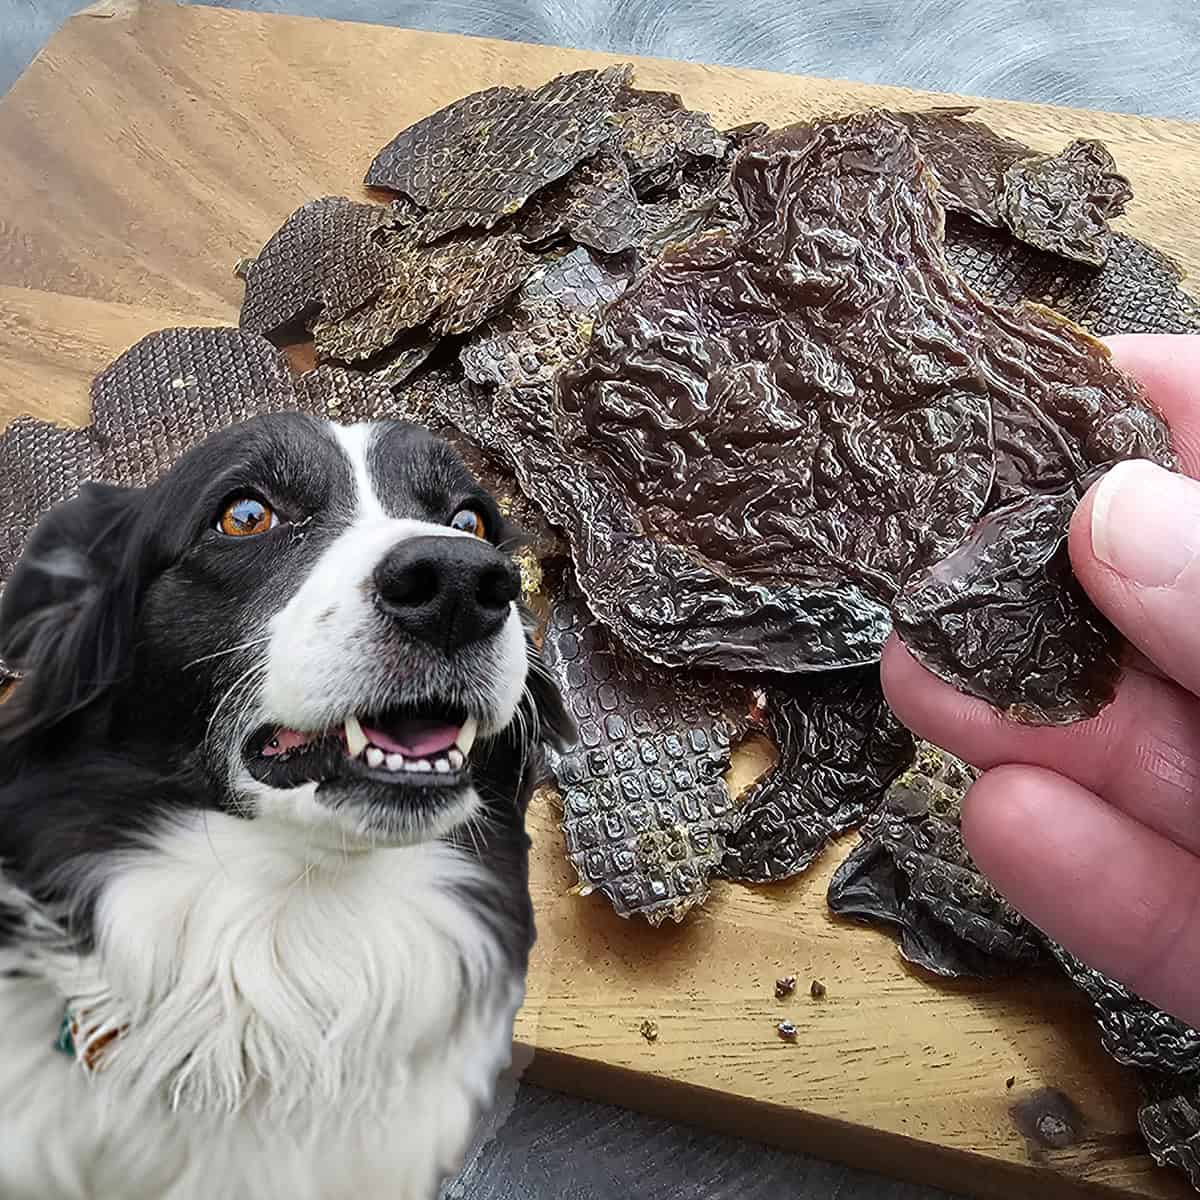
[0,814,523,1200]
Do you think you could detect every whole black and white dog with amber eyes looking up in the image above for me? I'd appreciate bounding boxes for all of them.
[0,413,572,1200]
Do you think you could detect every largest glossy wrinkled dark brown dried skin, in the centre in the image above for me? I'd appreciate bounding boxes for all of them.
[556,114,992,671]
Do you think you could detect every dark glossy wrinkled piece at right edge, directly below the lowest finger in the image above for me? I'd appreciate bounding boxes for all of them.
[1046,942,1200,1079]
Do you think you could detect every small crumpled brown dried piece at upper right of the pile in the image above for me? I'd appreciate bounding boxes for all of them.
[1000,139,1133,266]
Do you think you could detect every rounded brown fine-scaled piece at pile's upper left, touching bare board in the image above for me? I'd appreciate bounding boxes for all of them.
[240,196,392,334]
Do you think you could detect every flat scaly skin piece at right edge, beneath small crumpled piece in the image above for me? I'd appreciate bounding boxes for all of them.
[946,218,1200,337]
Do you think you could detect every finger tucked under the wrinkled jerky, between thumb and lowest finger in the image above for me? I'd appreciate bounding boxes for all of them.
[881,637,1200,854]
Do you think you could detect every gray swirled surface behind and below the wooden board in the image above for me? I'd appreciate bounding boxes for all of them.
[0,0,1200,1200]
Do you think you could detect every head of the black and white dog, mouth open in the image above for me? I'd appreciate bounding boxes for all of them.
[0,414,571,846]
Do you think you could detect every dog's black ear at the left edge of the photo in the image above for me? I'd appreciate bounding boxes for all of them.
[0,484,142,742]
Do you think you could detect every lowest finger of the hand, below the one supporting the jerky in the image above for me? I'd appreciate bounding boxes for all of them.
[962,767,1200,1025]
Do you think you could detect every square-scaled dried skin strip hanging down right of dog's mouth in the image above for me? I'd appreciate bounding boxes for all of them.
[542,583,749,925]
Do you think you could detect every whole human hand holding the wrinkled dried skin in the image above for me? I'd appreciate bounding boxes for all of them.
[882,336,1200,1027]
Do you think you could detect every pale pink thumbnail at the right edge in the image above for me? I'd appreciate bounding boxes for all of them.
[1092,458,1200,588]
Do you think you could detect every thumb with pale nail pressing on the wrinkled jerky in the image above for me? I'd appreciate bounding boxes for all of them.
[1070,460,1200,696]
